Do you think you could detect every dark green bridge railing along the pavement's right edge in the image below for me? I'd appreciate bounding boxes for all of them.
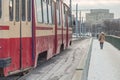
[106,35,120,50]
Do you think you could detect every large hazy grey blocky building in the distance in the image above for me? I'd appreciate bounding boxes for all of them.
[86,9,114,26]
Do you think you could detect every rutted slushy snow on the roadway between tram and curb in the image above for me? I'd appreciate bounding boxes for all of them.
[20,39,90,80]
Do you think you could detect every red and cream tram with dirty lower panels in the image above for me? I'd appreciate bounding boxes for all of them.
[0,0,72,76]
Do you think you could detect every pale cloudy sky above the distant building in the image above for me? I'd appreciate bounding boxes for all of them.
[64,0,120,18]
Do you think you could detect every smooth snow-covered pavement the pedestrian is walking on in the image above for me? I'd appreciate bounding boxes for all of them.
[88,39,120,80]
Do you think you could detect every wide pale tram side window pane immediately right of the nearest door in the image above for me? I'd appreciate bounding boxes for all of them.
[36,0,44,22]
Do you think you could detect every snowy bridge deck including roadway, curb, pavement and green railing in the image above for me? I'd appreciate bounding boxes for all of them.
[0,36,120,80]
